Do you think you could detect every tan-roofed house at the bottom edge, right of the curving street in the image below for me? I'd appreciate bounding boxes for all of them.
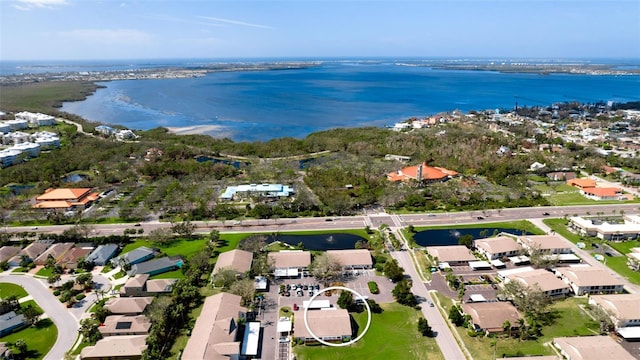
[80,335,147,360]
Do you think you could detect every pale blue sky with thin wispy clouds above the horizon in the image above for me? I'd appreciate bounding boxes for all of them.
[0,0,640,60]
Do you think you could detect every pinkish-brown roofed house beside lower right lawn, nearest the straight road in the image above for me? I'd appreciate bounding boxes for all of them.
[462,301,521,334]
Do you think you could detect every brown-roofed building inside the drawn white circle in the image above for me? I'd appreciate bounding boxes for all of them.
[293,308,353,343]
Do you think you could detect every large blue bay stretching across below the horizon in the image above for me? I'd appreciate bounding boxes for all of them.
[6,61,640,141]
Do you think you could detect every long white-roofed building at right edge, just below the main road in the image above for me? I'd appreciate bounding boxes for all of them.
[568,214,640,241]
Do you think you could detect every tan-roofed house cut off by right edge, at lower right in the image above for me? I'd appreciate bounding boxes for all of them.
[589,294,640,328]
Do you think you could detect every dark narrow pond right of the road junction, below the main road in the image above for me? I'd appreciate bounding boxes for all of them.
[413,228,533,246]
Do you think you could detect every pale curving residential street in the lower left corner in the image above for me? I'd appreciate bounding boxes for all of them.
[0,275,78,360]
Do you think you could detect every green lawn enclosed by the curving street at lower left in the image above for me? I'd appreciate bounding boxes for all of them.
[0,319,58,359]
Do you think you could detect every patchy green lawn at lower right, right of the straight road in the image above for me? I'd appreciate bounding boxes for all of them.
[438,294,599,360]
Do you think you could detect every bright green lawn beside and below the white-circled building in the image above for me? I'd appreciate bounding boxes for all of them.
[294,303,444,360]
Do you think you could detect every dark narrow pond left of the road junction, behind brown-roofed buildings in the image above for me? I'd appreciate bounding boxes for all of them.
[267,233,366,251]
